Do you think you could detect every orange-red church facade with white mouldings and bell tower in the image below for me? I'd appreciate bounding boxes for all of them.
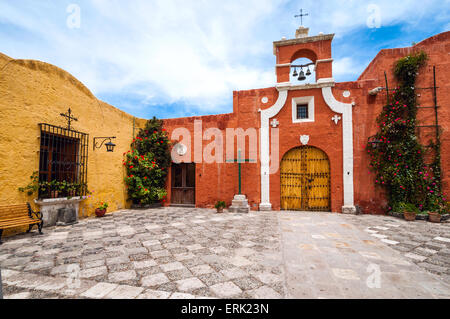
[161,32,450,214]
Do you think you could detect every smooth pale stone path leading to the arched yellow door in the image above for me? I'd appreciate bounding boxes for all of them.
[279,212,450,298]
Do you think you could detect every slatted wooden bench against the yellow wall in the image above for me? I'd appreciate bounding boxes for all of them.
[0,203,44,245]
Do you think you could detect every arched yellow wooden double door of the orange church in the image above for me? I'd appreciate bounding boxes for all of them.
[281,146,331,211]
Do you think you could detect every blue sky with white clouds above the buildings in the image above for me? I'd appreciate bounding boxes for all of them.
[0,0,450,118]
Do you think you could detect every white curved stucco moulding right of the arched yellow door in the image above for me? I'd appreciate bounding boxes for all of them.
[322,87,356,213]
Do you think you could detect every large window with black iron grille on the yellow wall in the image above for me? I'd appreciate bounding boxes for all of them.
[39,123,89,198]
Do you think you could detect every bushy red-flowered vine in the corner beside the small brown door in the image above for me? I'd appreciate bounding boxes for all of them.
[123,118,171,205]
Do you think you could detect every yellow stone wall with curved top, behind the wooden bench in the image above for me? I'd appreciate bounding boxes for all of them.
[0,53,145,238]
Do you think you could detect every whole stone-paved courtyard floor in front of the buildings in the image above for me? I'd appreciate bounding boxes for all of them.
[0,208,450,299]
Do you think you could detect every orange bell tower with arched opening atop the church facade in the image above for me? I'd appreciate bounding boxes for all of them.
[273,26,334,84]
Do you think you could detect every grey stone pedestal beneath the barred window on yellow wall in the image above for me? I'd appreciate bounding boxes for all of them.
[34,197,87,227]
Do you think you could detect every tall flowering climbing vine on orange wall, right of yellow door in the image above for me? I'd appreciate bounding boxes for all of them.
[366,52,446,211]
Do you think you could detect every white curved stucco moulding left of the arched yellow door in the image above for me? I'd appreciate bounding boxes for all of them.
[259,87,288,210]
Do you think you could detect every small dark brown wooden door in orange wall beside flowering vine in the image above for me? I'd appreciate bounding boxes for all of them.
[171,163,195,205]
